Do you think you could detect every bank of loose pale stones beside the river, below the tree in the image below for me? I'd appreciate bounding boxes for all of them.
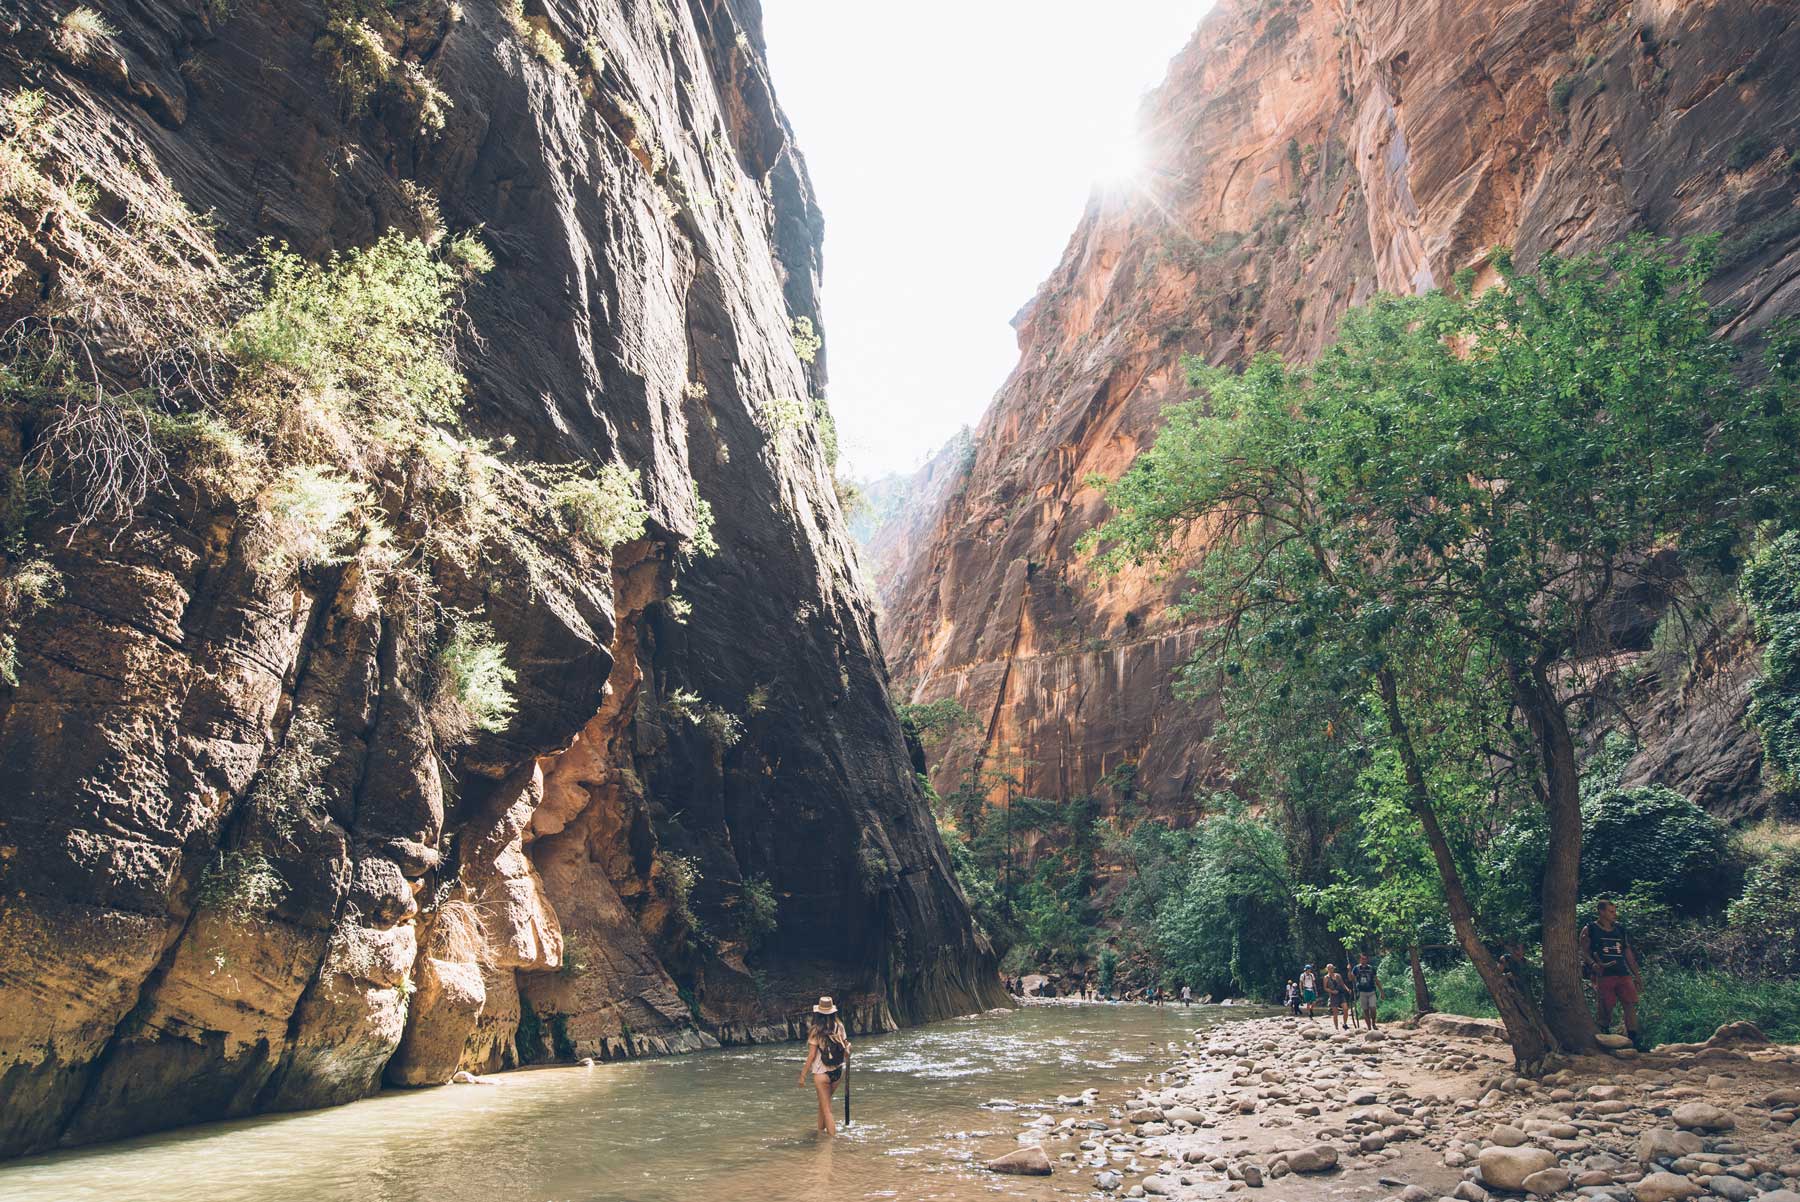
[992,1015,1800,1202]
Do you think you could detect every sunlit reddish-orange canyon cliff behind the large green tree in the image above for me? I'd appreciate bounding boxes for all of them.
[871,0,1800,808]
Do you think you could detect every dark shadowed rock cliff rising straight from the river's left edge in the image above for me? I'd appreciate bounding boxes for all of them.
[0,0,1004,1155]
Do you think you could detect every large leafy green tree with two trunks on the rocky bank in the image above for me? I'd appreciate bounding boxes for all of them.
[1098,239,1795,1063]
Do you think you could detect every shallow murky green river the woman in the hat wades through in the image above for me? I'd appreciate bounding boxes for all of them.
[0,1004,1260,1202]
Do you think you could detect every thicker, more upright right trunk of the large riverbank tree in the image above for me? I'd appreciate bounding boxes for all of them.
[1510,664,1598,1054]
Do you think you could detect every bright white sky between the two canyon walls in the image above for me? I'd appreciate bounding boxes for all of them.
[763,0,1211,479]
